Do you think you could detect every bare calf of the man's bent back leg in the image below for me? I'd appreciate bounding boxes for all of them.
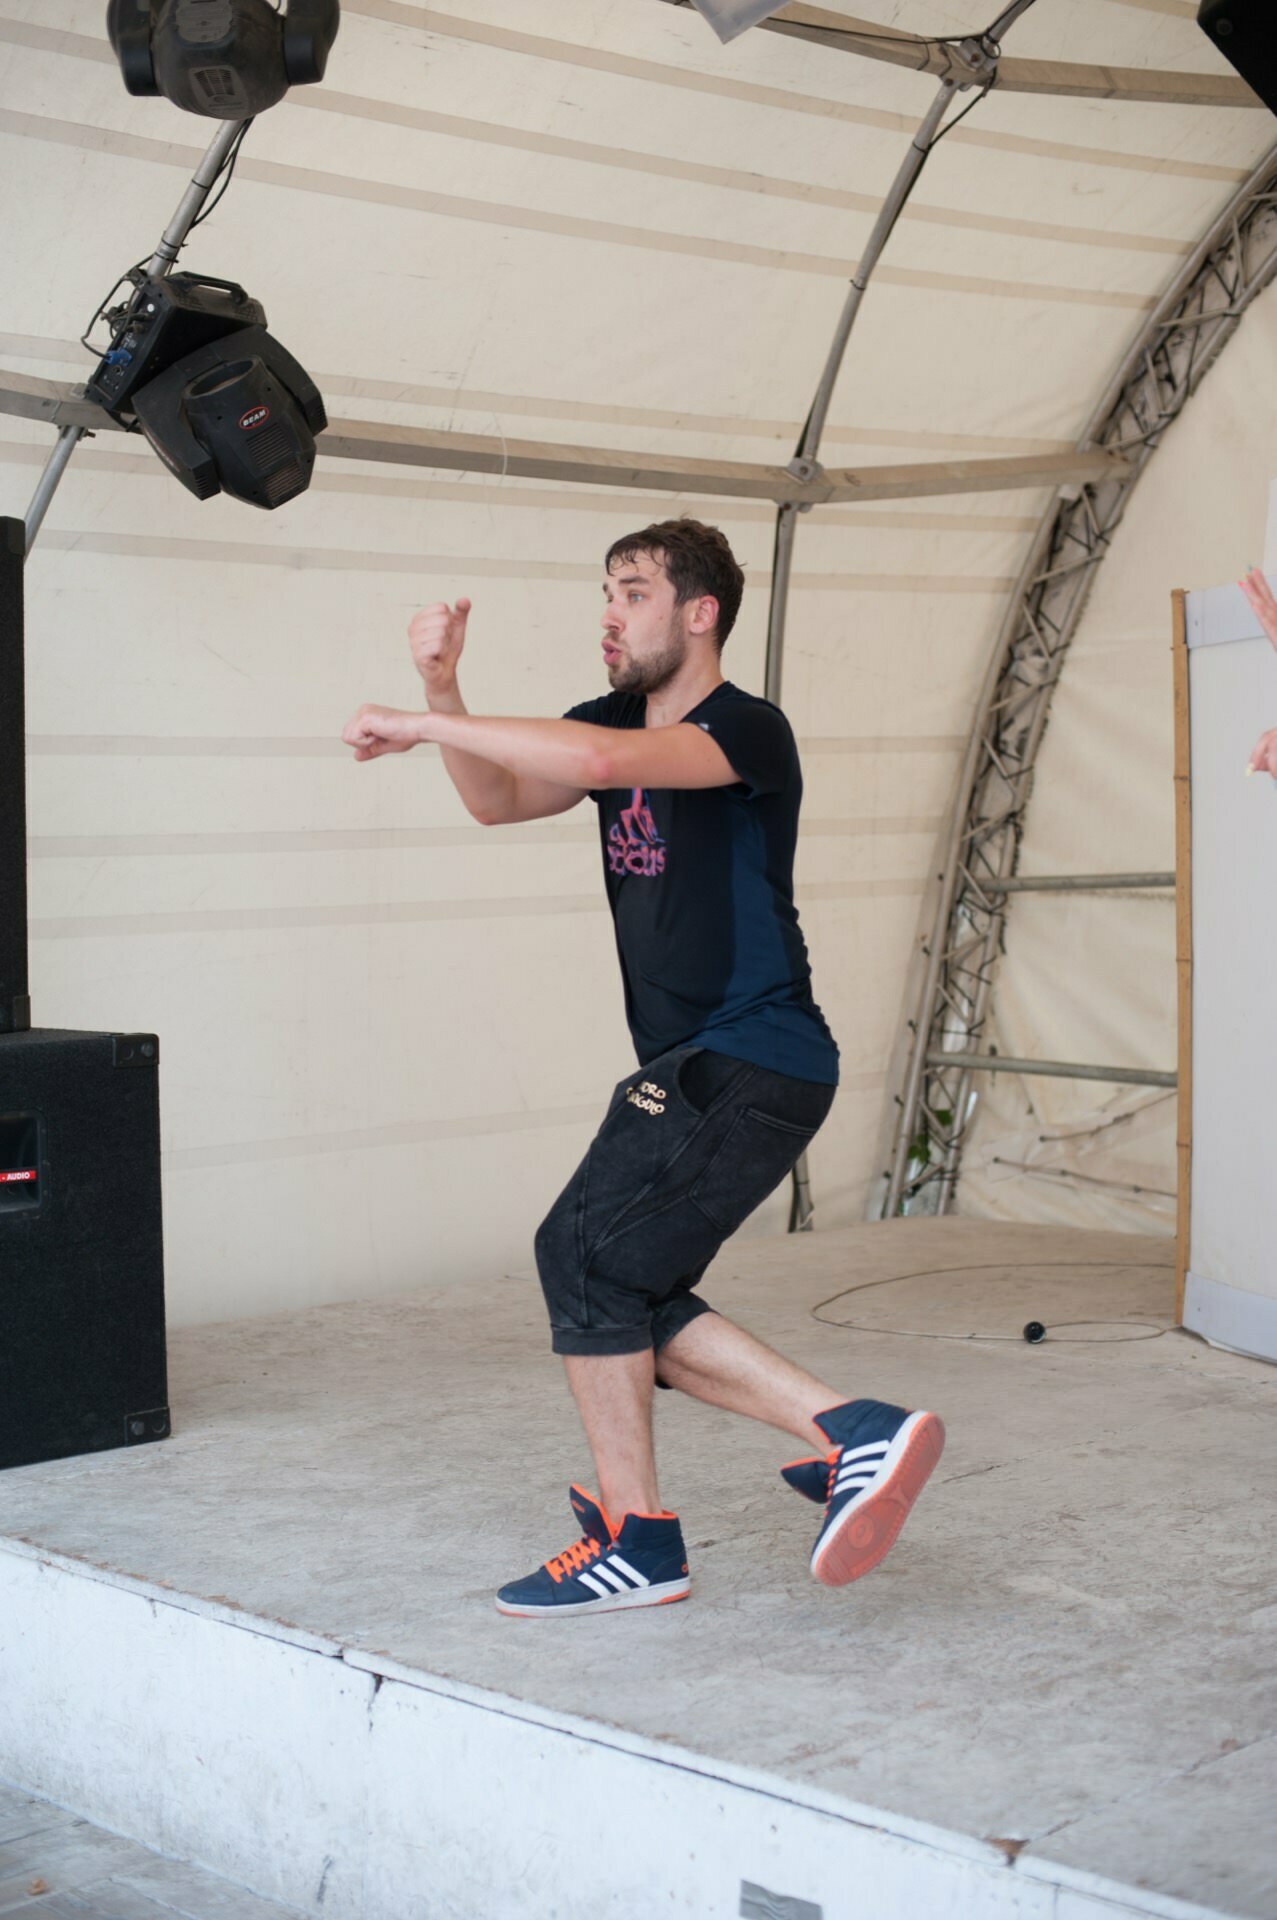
[657,1313,847,1453]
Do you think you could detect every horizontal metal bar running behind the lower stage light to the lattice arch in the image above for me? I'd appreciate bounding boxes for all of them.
[0,369,1127,507]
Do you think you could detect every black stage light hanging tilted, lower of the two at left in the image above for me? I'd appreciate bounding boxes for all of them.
[84,269,328,511]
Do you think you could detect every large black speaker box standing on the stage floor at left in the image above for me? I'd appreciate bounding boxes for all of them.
[0,1029,169,1467]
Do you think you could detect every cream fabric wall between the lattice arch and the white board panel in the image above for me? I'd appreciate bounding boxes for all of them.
[958,266,1277,1235]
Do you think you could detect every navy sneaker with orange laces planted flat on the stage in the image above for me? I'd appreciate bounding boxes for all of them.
[489,1486,691,1615]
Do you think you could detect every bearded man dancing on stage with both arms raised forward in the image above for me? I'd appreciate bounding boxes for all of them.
[342,518,945,1615]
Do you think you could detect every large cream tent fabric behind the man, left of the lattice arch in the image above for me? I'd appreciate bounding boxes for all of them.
[0,0,1269,1321]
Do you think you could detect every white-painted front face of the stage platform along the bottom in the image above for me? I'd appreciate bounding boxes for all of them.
[0,1538,1219,1920]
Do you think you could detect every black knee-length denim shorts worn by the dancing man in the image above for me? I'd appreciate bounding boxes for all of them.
[536,1046,835,1354]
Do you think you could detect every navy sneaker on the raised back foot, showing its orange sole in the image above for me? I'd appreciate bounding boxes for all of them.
[780,1400,945,1586]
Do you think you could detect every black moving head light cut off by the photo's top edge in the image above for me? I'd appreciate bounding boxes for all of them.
[106,0,342,119]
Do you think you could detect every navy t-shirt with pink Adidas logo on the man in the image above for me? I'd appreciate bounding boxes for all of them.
[565,680,837,1087]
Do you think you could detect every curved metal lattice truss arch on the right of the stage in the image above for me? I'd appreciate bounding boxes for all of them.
[872,148,1277,1219]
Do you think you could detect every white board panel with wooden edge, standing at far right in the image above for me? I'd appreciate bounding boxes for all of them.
[1185,588,1277,1359]
